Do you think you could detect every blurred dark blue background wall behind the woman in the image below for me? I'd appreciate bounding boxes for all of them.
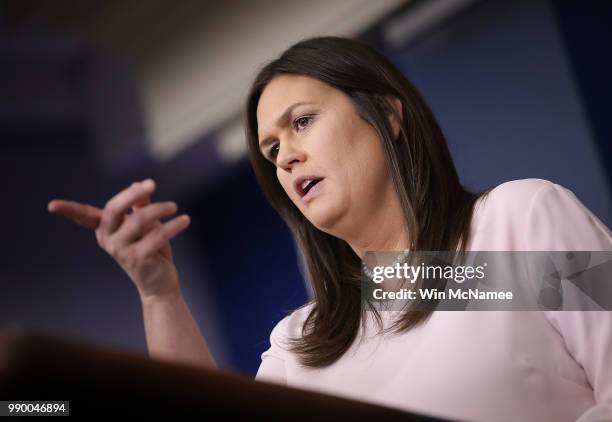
[0,0,612,374]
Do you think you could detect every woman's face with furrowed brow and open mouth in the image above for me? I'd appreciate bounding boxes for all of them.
[257,75,401,237]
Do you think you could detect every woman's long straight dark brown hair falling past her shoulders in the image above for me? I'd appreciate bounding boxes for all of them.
[245,37,491,368]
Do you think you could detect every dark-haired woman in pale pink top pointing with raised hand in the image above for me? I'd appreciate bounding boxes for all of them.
[49,37,612,422]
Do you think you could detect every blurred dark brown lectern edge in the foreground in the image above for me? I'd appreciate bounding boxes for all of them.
[0,326,450,422]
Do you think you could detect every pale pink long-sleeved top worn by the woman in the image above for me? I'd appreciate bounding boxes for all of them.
[255,179,612,422]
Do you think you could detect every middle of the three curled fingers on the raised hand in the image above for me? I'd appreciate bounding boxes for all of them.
[111,201,178,245]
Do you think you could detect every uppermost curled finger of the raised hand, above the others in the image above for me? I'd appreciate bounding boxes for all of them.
[100,179,155,235]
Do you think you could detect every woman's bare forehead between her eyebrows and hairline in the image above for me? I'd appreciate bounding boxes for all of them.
[257,75,335,130]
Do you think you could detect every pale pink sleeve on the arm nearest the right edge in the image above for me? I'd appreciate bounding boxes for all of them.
[527,183,612,422]
